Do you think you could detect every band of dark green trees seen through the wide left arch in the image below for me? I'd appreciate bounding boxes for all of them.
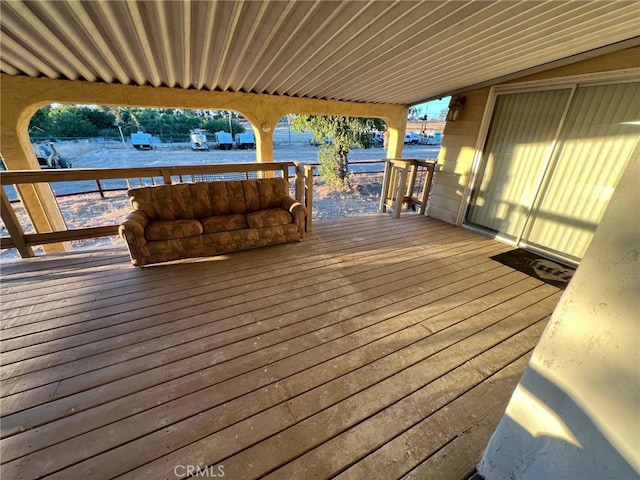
[29,105,245,141]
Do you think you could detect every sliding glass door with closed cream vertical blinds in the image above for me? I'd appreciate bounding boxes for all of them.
[465,83,640,262]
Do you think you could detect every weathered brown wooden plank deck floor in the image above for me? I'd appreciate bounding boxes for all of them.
[0,215,559,480]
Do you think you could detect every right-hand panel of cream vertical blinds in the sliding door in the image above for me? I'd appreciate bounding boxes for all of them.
[524,83,640,259]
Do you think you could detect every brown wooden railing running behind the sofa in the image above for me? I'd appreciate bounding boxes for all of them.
[0,162,313,258]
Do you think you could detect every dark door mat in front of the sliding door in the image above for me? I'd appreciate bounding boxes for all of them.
[490,249,576,290]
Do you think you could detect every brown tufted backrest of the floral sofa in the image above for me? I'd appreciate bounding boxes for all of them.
[128,178,289,221]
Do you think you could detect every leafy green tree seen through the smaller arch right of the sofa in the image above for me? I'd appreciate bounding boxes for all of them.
[289,115,385,184]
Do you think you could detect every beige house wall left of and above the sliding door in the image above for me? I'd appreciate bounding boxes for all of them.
[429,47,640,224]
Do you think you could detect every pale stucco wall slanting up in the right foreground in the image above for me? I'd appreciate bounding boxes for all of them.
[478,151,640,480]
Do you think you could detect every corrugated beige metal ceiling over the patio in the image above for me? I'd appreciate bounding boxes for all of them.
[0,0,640,105]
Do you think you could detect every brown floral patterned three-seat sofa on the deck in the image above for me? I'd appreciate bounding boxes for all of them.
[119,178,307,266]
